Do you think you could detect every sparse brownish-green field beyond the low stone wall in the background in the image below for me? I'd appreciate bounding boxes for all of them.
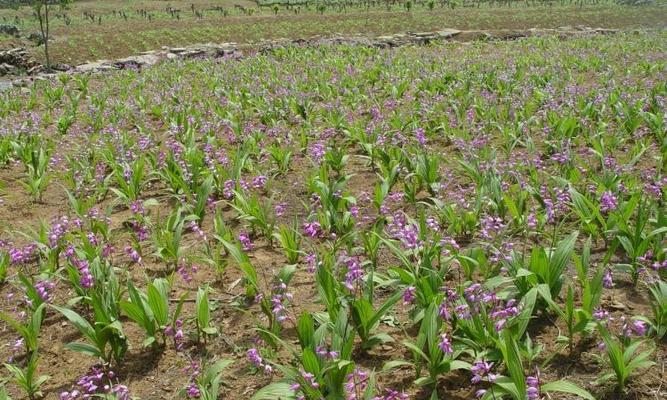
[0,0,667,65]
